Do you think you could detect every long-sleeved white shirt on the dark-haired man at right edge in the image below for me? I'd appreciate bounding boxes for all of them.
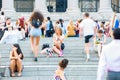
[97,40,120,80]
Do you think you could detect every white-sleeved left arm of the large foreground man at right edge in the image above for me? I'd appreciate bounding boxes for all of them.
[97,48,107,80]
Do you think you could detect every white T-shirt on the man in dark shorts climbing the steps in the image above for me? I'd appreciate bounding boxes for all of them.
[79,18,96,36]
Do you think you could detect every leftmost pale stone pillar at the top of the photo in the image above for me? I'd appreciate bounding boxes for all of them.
[1,0,15,17]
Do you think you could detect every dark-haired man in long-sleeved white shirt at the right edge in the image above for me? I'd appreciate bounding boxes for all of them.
[97,28,120,80]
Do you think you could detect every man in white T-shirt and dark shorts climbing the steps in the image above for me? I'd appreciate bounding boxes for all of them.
[79,13,96,61]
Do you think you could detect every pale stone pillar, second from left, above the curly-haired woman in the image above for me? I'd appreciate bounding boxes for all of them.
[35,0,48,14]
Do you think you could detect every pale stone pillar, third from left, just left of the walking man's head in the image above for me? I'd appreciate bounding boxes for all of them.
[67,0,80,19]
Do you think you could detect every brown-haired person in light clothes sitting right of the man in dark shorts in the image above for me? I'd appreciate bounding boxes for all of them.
[94,30,106,57]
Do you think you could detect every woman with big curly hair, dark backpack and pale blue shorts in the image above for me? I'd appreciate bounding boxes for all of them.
[29,11,44,61]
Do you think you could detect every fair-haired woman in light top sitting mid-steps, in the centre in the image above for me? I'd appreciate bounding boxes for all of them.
[53,27,64,57]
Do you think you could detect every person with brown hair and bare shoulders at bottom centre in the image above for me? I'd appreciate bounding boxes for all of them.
[55,59,69,80]
